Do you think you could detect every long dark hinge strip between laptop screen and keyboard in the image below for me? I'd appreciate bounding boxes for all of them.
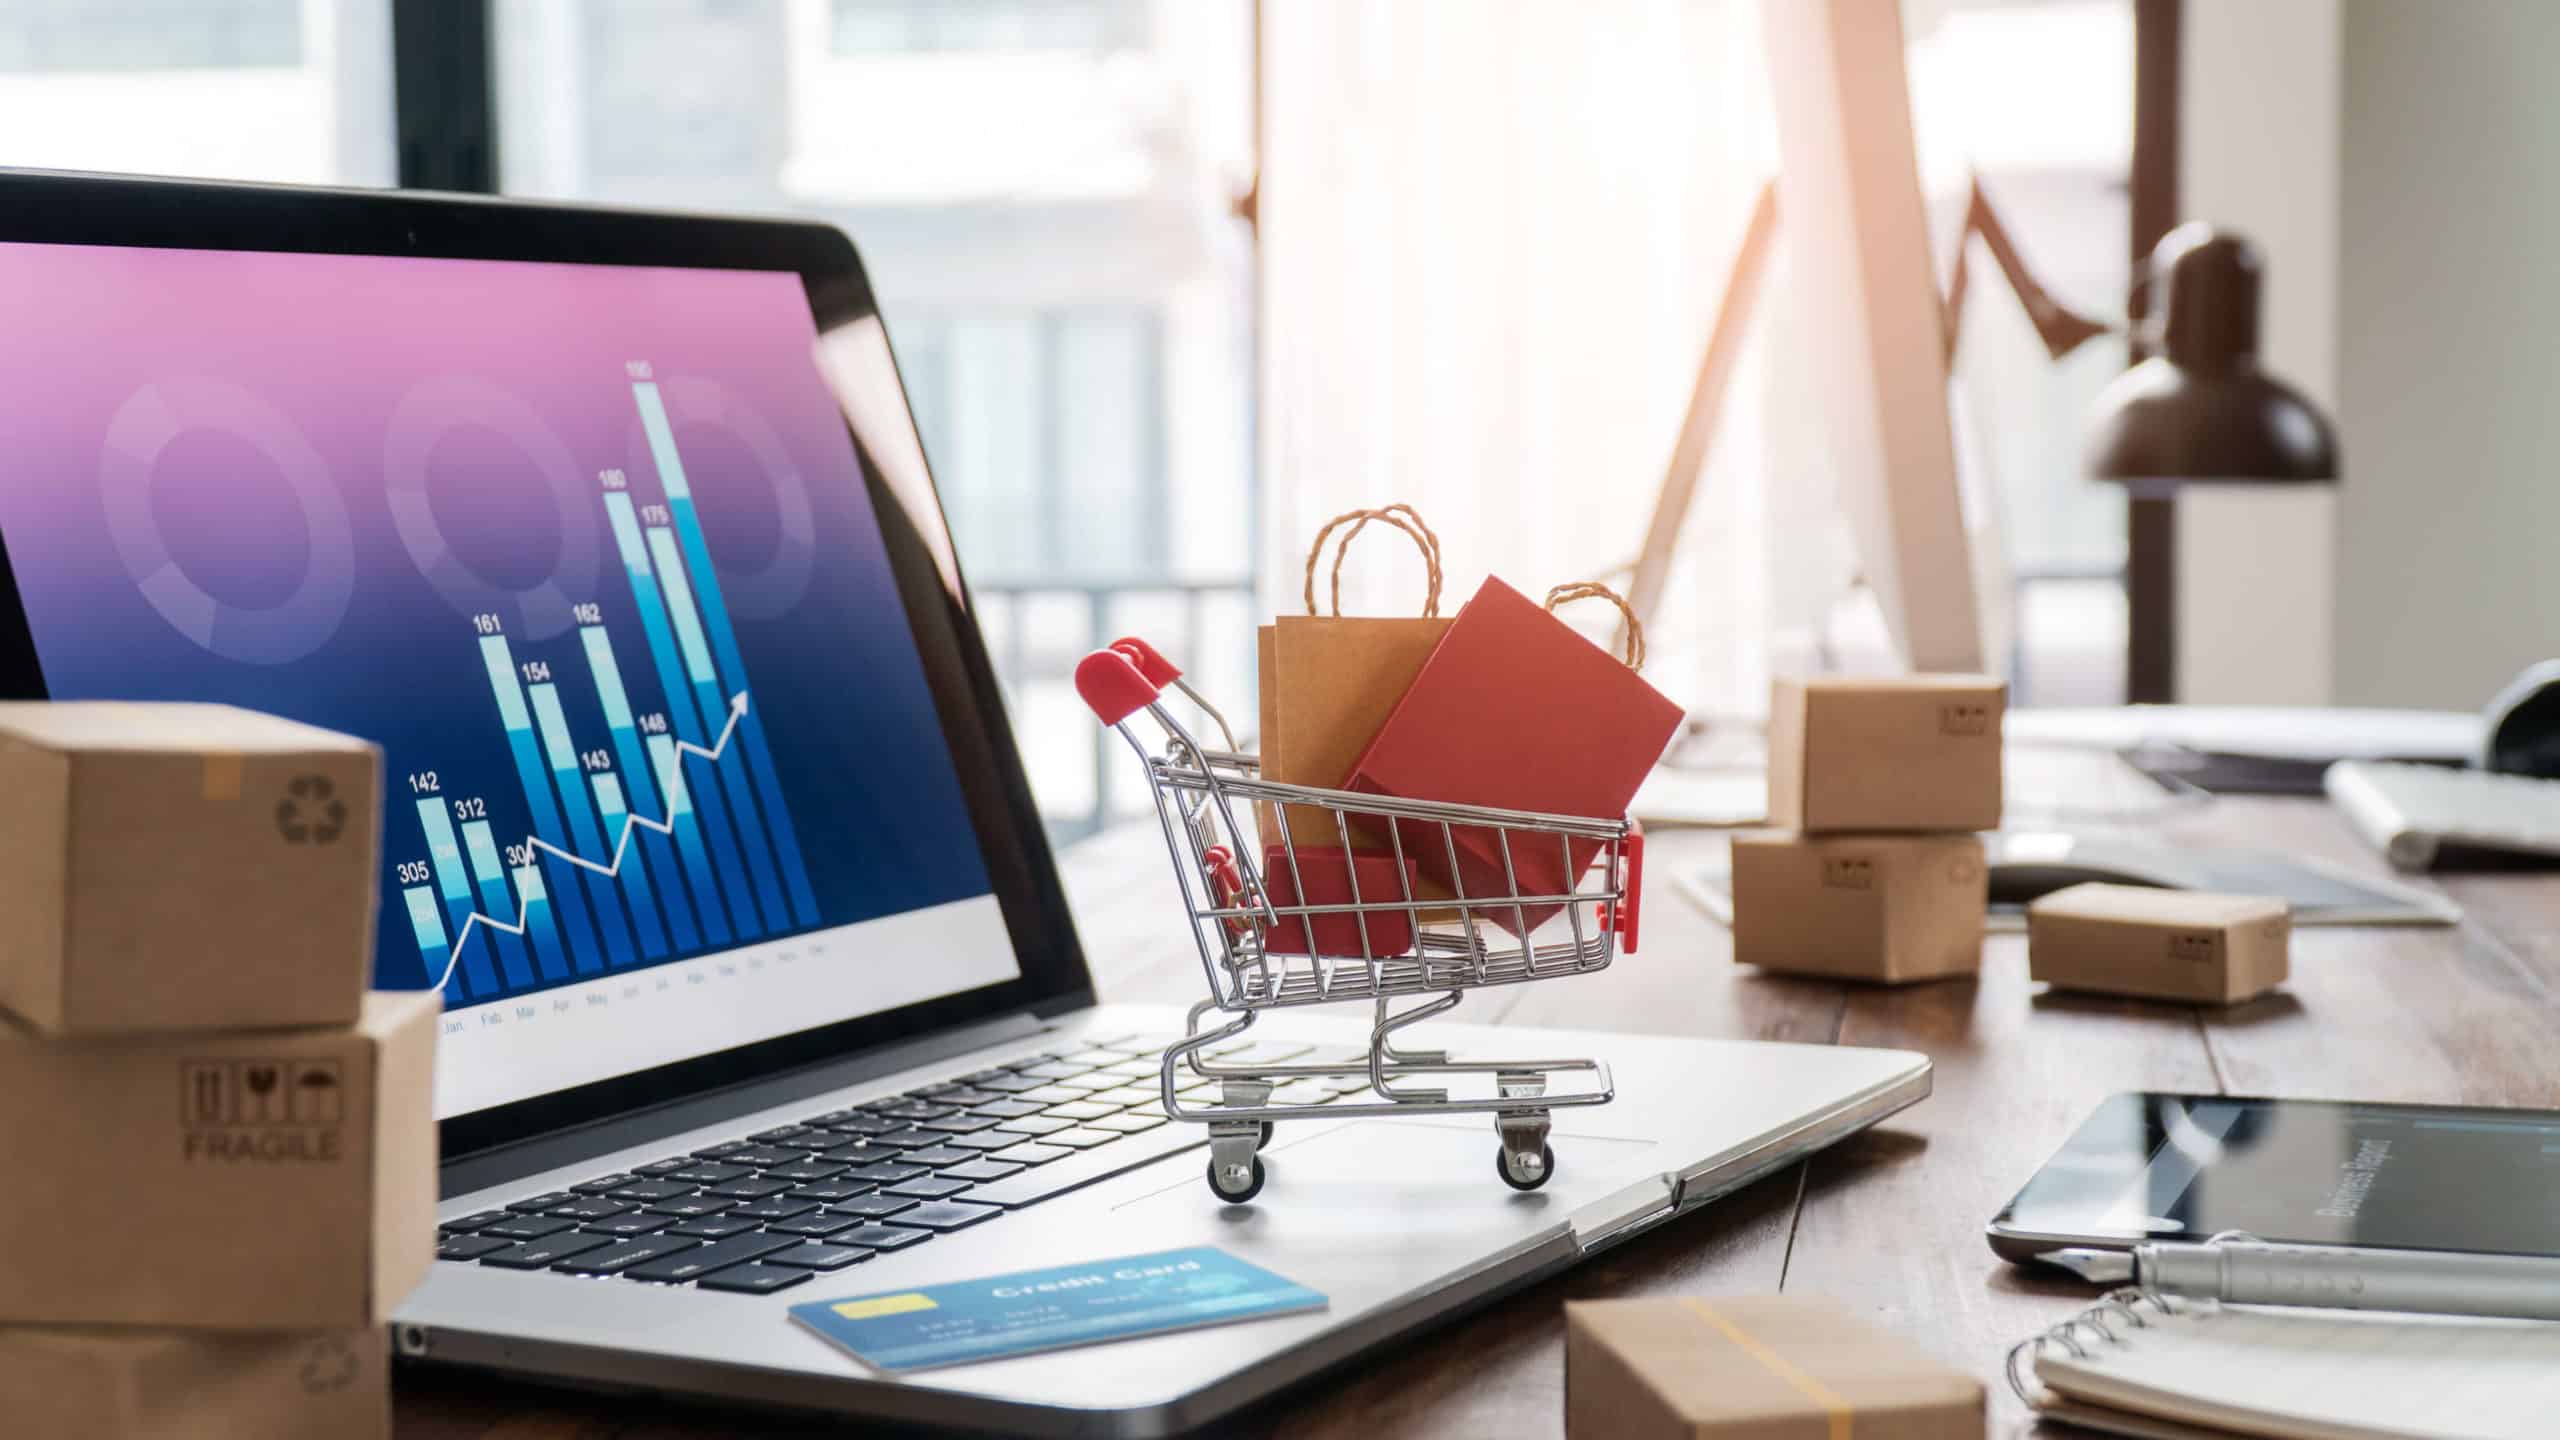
[438,1012,1050,1197]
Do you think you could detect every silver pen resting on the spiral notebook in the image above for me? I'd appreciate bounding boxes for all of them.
[2043,1235,2560,1320]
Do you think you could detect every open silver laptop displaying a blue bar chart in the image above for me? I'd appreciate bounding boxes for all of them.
[0,172,1930,1435]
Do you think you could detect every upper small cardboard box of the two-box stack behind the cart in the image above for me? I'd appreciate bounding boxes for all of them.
[1769,674,2010,833]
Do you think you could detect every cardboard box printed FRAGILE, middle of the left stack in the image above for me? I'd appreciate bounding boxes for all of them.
[0,992,443,1330]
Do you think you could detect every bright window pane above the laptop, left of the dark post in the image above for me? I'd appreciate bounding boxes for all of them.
[0,0,394,184]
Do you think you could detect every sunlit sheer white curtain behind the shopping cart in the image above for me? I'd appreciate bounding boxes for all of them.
[1262,0,1812,710]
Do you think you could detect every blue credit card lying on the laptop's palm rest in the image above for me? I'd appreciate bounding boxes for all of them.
[791,1245,1326,1371]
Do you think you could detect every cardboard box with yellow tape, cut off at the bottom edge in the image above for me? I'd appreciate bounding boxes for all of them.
[1564,1294,1987,1440]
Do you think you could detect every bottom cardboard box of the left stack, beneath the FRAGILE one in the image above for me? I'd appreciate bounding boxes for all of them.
[0,1327,392,1440]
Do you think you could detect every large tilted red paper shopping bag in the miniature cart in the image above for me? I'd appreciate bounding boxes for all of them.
[1344,579,1682,930]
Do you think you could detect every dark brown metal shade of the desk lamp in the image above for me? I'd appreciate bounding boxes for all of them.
[2089,223,2337,495]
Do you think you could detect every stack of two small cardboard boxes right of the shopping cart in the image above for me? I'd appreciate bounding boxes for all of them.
[1733,674,2007,984]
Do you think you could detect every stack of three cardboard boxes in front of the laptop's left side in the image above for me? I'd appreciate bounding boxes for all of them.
[0,705,440,1440]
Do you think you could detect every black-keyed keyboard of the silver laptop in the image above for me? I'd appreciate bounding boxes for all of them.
[435,1035,1367,1294]
